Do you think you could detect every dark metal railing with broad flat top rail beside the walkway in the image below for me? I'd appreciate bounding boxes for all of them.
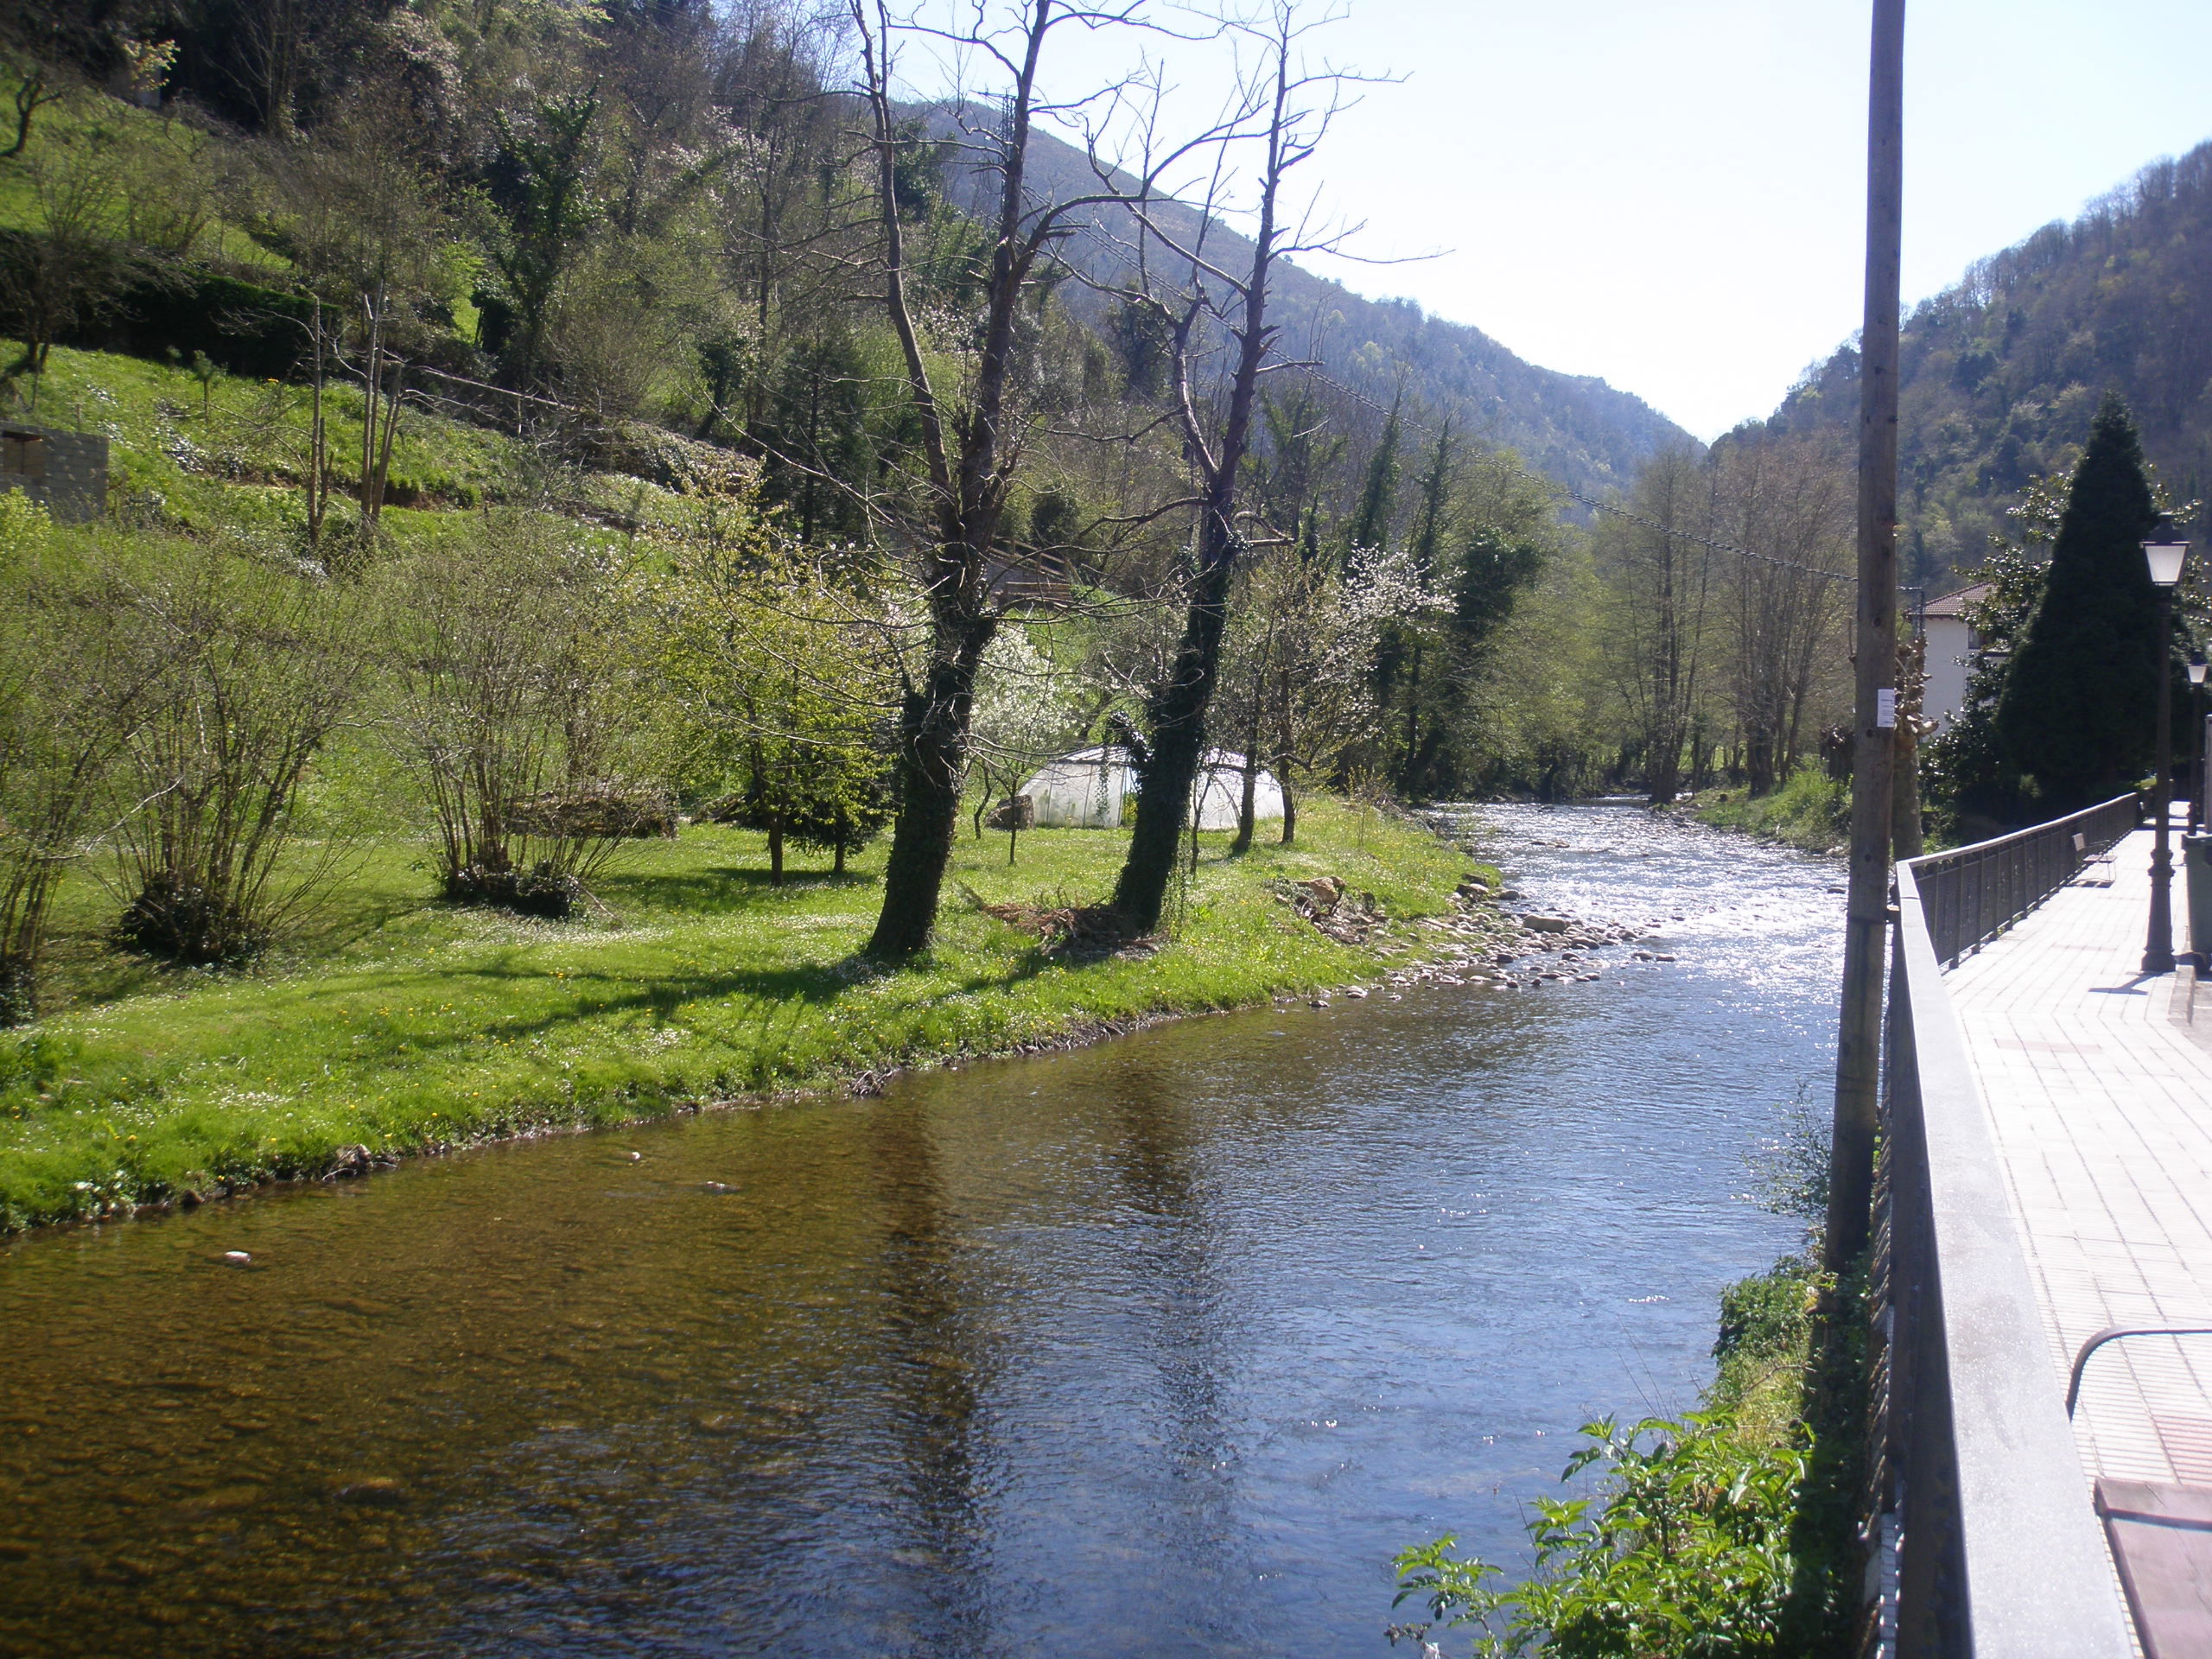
[1867,814,2134,1659]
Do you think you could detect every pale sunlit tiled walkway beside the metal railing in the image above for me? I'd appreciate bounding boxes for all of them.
[1944,830,2212,1486]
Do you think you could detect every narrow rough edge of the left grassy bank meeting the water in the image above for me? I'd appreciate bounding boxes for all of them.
[0,812,1557,1248]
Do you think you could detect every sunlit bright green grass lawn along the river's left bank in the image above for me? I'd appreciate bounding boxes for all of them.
[0,798,1471,1232]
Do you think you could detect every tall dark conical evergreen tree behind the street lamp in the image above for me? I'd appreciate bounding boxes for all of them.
[1998,394,2168,810]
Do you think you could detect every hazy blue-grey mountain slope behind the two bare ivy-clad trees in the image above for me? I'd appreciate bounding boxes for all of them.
[940,118,1697,495]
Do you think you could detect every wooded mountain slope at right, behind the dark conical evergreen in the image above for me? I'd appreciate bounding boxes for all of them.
[1767,143,2212,586]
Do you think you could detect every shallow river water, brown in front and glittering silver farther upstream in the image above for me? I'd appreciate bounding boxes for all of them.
[0,807,1842,1659]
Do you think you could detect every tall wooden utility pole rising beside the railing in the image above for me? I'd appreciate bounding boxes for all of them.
[1825,0,1904,1269]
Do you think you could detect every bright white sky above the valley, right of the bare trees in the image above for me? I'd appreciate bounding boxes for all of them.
[1274,0,2212,438]
